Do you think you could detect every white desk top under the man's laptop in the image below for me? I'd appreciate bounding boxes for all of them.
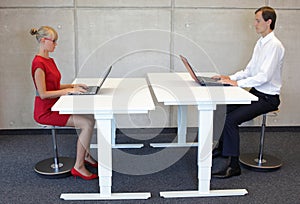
[147,72,258,105]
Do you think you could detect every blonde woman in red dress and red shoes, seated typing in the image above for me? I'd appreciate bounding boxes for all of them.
[30,26,98,180]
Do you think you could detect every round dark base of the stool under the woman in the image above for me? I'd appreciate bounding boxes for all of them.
[34,157,75,178]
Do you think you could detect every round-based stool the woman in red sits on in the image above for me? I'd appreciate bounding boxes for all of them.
[34,125,75,178]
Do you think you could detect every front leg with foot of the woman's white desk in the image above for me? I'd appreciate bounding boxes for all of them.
[60,114,151,200]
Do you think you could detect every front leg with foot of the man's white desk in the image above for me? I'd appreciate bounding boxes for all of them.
[160,105,248,198]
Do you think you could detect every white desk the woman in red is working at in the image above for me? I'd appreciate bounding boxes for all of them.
[52,78,155,200]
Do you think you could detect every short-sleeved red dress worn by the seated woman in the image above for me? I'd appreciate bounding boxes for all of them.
[31,55,70,126]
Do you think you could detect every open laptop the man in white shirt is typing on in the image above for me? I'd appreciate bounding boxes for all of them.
[179,55,230,86]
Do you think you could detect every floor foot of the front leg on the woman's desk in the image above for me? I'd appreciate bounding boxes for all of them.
[60,193,151,200]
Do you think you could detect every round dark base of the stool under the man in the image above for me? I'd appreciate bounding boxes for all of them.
[240,153,282,171]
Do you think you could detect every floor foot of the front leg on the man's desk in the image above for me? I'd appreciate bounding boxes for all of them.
[160,189,248,198]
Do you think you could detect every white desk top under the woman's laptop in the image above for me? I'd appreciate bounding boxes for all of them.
[52,78,155,114]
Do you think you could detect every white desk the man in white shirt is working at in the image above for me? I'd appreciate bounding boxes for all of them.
[148,73,257,198]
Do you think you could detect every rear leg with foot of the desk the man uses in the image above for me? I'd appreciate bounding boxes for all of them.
[150,105,197,147]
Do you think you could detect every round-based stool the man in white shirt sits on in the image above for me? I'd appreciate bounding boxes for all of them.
[240,111,282,171]
